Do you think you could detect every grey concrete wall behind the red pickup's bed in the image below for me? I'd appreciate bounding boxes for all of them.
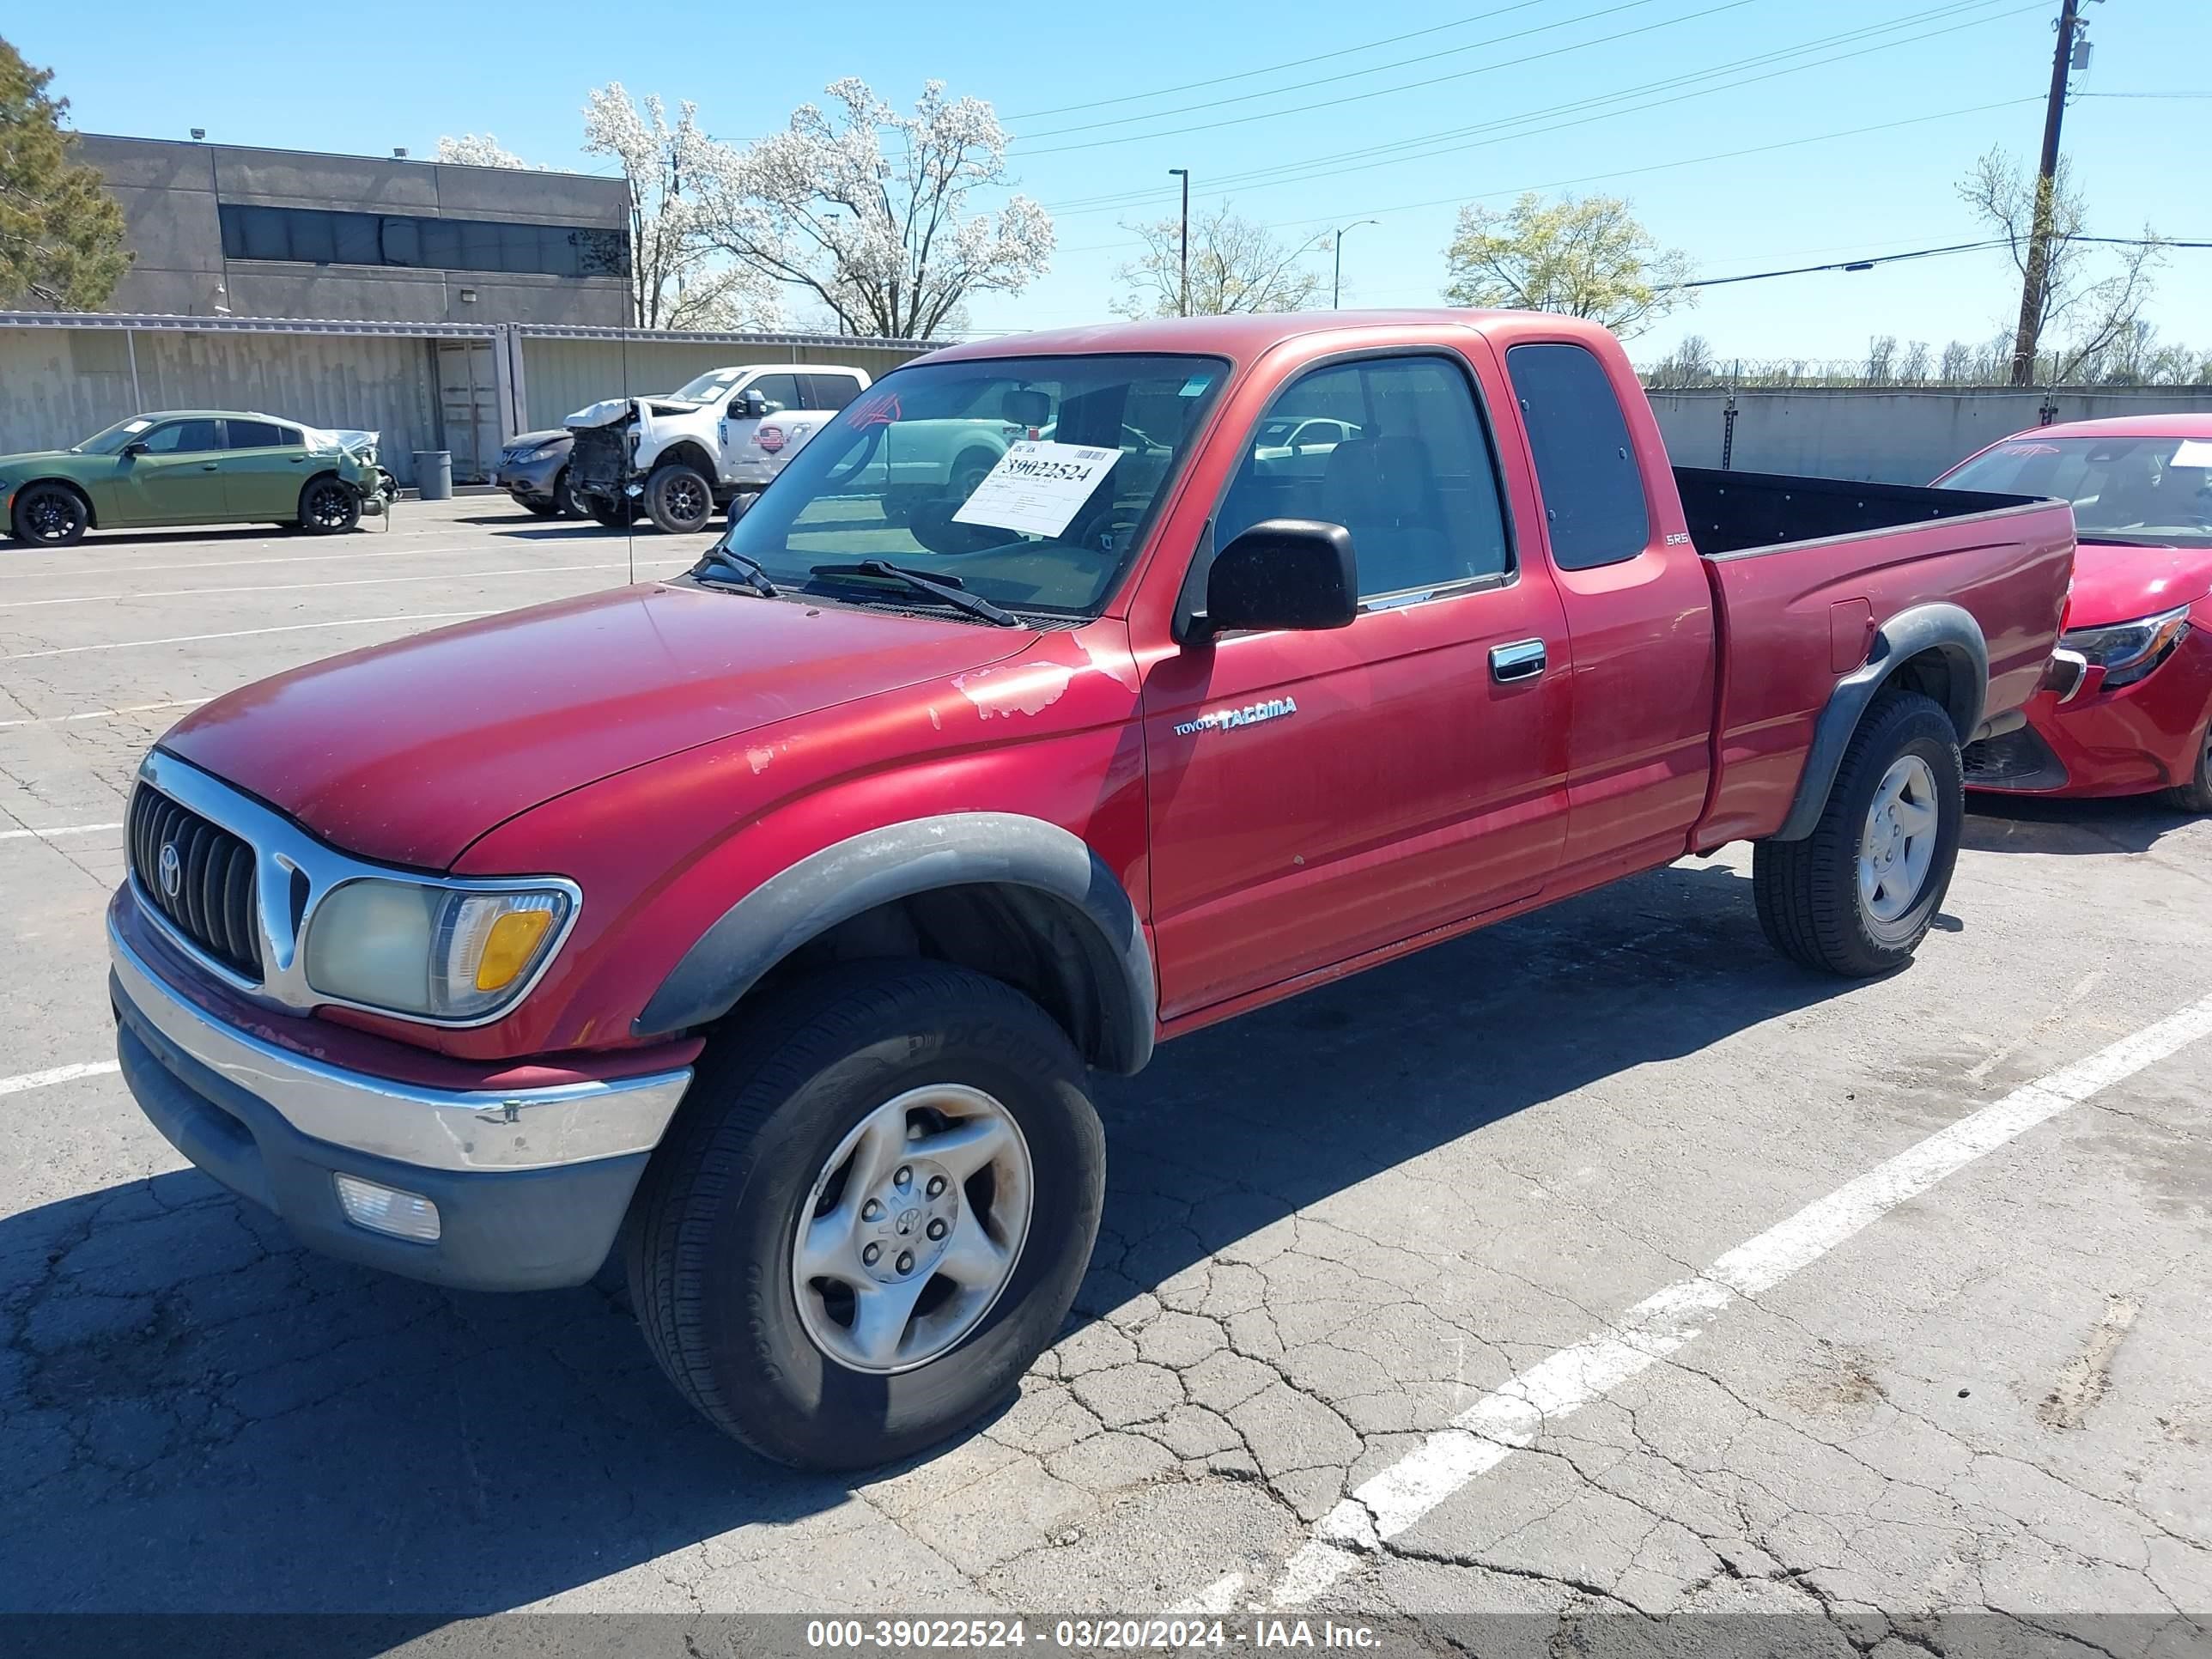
[1652,387,2212,484]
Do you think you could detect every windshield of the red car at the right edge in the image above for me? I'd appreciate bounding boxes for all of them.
[1942,434,2212,549]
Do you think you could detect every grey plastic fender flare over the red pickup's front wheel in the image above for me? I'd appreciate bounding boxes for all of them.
[630,811,1159,1073]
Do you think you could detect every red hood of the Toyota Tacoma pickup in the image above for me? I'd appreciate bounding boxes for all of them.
[161,584,1036,869]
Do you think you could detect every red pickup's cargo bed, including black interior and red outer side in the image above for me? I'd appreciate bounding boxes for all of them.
[1674,467,2073,849]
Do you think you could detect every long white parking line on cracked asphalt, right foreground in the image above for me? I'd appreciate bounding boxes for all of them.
[1176,995,2212,1613]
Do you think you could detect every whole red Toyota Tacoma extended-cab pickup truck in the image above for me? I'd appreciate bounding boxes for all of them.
[108,312,2073,1467]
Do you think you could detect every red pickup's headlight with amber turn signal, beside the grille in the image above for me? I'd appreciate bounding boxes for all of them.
[307,876,575,1020]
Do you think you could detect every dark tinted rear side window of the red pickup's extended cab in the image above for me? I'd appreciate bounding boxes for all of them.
[1506,343,1652,571]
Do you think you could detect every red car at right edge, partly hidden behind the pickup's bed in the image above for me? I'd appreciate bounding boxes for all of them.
[1936,414,2212,811]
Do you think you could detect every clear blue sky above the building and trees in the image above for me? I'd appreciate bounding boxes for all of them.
[7,0,2212,361]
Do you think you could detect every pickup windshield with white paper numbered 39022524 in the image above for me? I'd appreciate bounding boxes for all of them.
[723,354,1228,619]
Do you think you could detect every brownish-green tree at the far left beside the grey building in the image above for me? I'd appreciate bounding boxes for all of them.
[0,40,131,312]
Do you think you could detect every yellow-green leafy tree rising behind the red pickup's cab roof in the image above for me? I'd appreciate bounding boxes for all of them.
[1444,191,1697,337]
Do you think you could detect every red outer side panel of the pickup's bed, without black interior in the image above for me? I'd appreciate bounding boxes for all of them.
[1694,502,2075,848]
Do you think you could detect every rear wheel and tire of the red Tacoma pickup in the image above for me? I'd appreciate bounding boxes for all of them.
[1752,692,1966,980]
